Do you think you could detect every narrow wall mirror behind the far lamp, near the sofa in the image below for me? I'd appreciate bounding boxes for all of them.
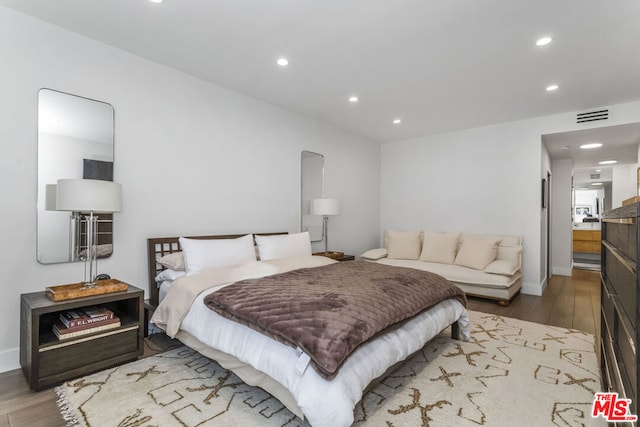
[300,151,324,242]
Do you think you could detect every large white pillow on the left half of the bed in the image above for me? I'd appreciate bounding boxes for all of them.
[179,234,256,276]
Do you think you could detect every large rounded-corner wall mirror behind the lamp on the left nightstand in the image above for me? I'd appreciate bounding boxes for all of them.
[36,89,114,264]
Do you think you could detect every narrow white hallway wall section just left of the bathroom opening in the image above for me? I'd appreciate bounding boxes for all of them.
[549,159,573,276]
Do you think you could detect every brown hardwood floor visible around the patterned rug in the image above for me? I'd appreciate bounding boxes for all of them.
[0,270,600,427]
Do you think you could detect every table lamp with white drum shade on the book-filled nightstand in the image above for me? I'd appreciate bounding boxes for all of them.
[56,179,122,287]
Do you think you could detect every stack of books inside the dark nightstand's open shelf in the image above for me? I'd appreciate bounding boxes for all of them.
[53,306,120,340]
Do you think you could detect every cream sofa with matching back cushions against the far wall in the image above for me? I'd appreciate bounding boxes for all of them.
[361,231,522,305]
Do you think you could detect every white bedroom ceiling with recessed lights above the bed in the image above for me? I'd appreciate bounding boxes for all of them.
[0,0,640,142]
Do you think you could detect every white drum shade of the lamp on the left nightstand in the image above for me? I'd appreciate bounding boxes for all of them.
[56,179,122,213]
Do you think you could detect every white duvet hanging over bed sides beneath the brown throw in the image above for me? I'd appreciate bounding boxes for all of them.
[181,276,469,427]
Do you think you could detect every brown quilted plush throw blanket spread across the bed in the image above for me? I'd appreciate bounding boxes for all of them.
[204,261,466,379]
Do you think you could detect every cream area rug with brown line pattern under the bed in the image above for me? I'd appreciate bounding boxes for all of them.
[56,312,605,427]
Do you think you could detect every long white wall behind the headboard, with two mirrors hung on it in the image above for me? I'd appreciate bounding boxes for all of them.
[0,7,380,371]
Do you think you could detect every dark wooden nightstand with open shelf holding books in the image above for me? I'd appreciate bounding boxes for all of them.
[20,285,144,390]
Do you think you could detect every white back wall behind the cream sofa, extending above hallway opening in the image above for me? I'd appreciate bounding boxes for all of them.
[380,102,640,295]
